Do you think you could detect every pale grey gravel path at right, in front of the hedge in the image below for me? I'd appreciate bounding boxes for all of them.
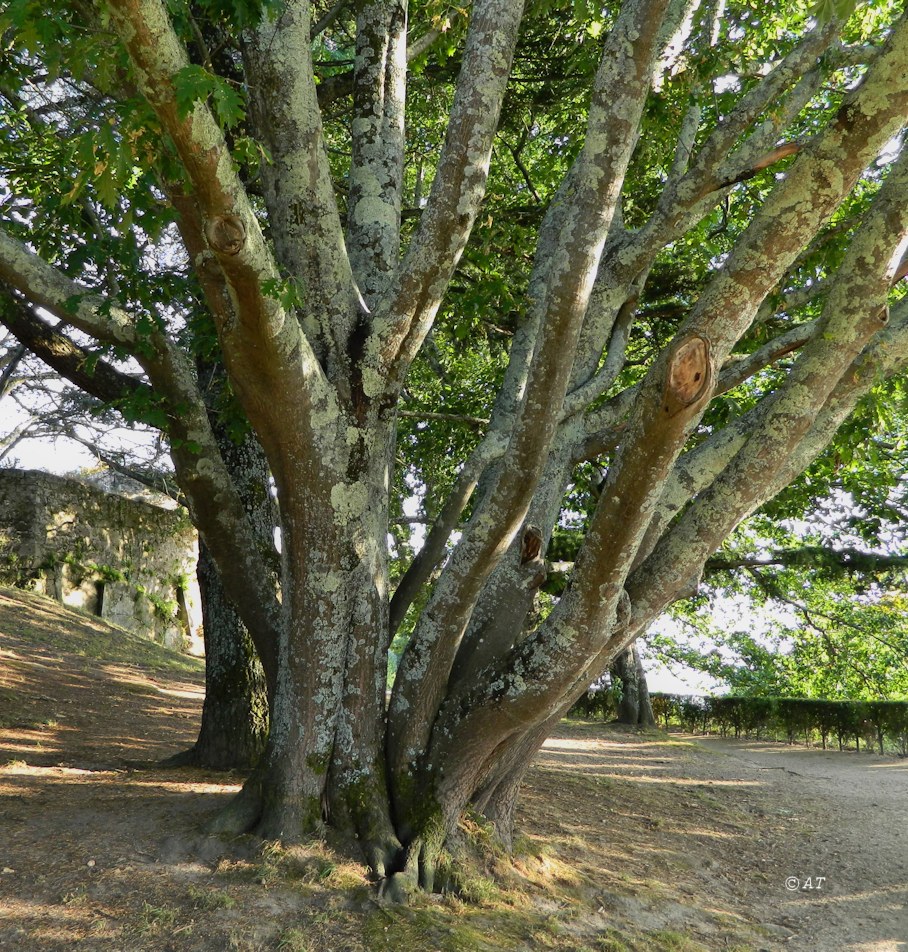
[697,737,908,952]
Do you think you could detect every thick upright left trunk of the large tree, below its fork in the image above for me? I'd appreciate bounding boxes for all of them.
[214,414,401,877]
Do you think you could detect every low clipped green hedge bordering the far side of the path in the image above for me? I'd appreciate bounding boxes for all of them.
[571,690,908,756]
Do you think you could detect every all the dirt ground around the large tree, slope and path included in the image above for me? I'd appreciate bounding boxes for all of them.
[0,590,908,952]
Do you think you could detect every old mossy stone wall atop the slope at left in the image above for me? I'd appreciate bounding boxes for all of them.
[0,469,201,650]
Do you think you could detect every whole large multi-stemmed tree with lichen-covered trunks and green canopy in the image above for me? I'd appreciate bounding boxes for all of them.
[0,0,908,894]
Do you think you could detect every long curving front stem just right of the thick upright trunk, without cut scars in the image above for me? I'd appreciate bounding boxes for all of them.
[389,0,667,784]
